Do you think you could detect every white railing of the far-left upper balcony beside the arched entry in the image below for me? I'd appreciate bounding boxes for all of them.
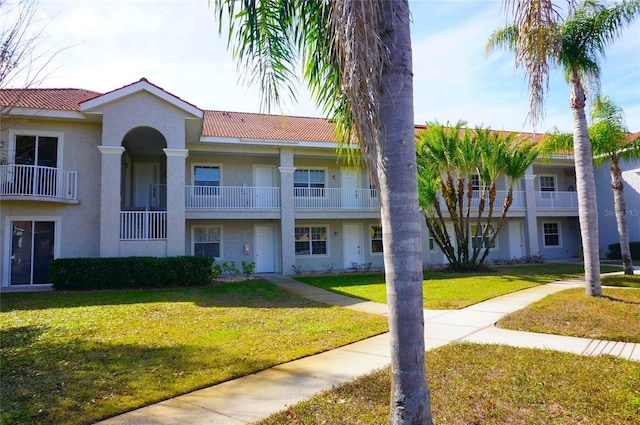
[0,164,78,200]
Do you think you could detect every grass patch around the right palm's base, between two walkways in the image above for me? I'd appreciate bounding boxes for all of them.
[498,284,640,343]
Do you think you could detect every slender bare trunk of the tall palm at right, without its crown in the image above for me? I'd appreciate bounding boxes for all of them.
[569,70,602,297]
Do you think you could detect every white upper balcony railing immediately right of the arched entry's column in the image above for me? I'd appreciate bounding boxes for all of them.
[185,186,280,209]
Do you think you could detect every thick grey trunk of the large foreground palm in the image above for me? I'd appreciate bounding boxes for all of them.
[372,0,432,424]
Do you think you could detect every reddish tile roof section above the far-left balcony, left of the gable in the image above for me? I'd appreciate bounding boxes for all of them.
[0,89,102,111]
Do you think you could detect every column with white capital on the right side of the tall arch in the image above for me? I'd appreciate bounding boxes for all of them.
[163,149,189,256]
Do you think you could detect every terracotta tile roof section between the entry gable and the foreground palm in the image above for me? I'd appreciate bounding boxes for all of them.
[202,111,335,142]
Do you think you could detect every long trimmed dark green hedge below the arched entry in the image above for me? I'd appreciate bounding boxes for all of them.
[51,256,213,290]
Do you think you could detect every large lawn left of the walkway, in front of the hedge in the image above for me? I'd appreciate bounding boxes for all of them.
[0,280,387,425]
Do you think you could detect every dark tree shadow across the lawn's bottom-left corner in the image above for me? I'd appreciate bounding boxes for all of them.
[0,326,277,424]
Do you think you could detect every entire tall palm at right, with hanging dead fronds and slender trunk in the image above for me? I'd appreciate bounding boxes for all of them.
[487,0,640,296]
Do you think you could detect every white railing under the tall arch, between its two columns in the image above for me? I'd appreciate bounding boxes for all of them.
[120,211,167,241]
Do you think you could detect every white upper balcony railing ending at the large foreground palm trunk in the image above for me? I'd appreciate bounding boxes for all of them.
[294,187,380,210]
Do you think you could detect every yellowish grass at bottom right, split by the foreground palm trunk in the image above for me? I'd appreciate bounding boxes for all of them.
[259,343,640,425]
